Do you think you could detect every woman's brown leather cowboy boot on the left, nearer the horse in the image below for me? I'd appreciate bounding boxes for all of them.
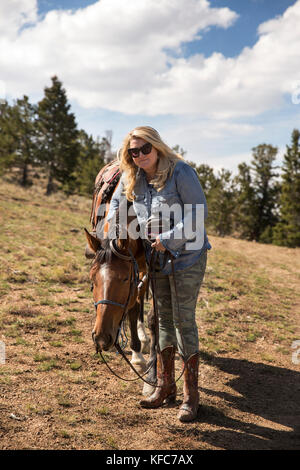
[140,346,176,408]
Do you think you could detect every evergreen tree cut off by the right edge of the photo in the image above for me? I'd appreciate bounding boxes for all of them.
[273,129,300,247]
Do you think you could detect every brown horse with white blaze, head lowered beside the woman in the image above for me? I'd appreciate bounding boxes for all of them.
[86,165,156,384]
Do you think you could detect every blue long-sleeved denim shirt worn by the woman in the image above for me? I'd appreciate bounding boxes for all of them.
[107,160,211,274]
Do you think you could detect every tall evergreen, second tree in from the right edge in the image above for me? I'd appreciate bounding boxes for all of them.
[251,144,279,243]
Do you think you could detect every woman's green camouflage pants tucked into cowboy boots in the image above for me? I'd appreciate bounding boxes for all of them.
[155,252,207,358]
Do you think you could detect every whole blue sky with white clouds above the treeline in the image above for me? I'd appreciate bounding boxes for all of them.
[0,0,300,171]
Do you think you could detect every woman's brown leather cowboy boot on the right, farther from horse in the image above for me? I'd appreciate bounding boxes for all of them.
[178,353,199,423]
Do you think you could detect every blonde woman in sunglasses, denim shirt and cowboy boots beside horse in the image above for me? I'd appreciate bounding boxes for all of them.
[108,126,211,422]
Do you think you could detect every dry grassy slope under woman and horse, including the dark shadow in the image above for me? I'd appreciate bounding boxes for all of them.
[0,182,300,451]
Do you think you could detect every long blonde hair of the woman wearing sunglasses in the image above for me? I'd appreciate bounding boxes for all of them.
[120,126,183,201]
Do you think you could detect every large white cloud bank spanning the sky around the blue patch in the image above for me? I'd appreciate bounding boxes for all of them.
[0,0,300,119]
